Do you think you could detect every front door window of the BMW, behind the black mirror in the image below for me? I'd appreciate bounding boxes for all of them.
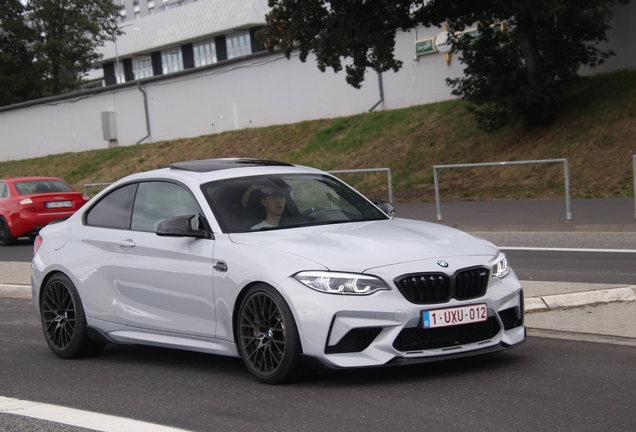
[130,182,201,232]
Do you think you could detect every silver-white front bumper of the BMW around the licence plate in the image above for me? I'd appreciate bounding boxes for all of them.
[279,273,526,368]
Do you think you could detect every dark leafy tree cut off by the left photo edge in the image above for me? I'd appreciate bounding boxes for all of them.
[0,0,42,106]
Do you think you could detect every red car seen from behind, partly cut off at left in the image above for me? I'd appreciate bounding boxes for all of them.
[0,177,88,246]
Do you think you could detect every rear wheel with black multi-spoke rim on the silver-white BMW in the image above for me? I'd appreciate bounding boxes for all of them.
[40,273,105,359]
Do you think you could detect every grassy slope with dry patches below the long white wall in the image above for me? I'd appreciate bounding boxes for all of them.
[0,71,636,202]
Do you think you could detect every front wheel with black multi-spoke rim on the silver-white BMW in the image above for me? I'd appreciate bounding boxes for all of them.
[238,284,302,384]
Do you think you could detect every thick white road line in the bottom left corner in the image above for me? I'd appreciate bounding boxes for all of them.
[0,396,191,432]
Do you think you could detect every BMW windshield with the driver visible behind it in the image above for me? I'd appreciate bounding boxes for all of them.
[201,174,388,233]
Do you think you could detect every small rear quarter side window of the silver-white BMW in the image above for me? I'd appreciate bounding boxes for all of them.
[86,184,137,229]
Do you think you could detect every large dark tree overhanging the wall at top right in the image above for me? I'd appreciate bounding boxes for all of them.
[258,0,629,129]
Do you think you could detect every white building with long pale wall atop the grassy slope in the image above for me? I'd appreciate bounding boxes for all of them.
[0,0,636,161]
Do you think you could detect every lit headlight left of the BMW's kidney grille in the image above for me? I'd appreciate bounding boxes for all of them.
[294,271,391,295]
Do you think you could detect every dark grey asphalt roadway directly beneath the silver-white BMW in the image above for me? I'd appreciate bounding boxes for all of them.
[0,299,636,432]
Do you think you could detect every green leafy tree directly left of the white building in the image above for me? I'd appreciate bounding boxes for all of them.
[26,0,119,95]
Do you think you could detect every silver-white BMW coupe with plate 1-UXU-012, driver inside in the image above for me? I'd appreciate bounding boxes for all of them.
[31,159,526,384]
